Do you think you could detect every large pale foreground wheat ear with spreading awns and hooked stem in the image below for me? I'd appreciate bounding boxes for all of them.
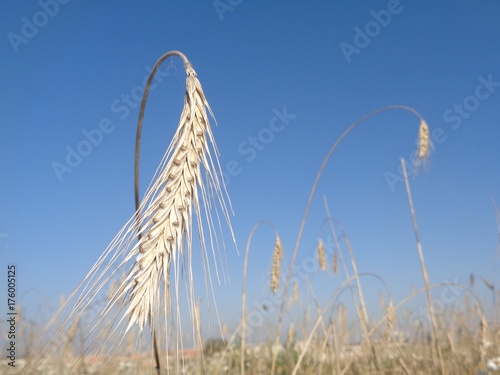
[30,51,234,373]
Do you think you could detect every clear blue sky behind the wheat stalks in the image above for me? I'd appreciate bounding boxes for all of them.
[0,0,500,340]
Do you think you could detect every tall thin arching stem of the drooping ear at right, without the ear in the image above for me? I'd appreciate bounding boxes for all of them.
[271,105,422,375]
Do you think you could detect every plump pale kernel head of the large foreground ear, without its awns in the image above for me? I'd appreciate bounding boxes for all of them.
[127,62,214,329]
